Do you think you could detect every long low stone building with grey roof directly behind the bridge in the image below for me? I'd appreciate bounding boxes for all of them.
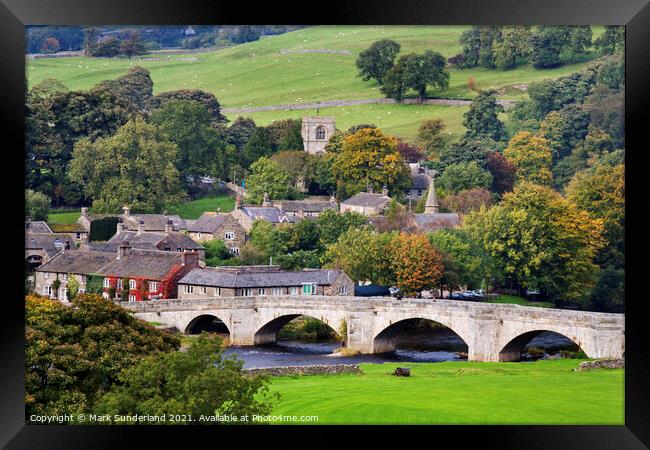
[178,266,354,299]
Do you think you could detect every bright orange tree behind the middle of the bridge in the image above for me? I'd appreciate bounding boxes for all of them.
[390,233,443,296]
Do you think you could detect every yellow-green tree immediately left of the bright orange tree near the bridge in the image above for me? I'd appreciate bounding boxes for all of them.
[323,227,393,285]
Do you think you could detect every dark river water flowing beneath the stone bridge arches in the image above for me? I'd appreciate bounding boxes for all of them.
[224,330,576,369]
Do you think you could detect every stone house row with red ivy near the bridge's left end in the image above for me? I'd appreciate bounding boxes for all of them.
[35,242,199,302]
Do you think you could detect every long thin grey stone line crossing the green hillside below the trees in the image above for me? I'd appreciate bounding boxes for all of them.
[221,98,515,114]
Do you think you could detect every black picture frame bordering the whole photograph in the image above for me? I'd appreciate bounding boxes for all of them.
[0,0,650,449]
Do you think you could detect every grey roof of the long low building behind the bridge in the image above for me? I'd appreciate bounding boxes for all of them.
[178,267,343,288]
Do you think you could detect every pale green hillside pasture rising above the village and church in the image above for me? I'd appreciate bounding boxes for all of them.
[27,26,601,139]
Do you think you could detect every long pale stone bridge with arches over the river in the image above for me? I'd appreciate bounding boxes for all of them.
[125,296,625,361]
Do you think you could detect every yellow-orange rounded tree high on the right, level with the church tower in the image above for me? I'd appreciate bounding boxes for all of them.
[503,131,553,185]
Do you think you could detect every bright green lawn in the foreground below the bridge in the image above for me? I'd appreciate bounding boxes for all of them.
[264,359,624,425]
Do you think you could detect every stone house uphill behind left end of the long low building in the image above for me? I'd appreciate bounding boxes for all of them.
[187,212,246,255]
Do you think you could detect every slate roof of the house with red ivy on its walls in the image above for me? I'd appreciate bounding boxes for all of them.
[97,249,183,280]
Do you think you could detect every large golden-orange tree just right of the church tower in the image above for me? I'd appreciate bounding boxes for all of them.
[332,128,411,195]
